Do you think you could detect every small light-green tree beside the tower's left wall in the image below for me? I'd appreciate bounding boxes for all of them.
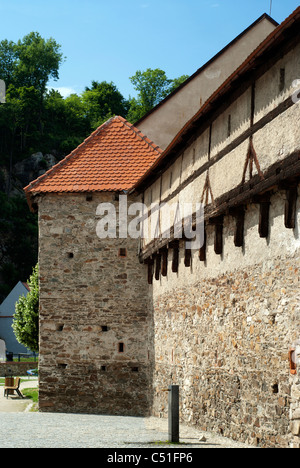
[12,265,39,352]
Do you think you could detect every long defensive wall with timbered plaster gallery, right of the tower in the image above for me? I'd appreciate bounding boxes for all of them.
[140,28,300,447]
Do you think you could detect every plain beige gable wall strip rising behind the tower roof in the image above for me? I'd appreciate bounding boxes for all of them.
[136,15,276,150]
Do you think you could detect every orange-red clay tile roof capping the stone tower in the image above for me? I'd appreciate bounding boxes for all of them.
[24,116,162,198]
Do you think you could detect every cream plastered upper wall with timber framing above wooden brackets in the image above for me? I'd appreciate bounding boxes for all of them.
[143,39,300,252]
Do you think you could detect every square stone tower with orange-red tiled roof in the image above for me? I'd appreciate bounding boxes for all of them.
[25,117,160,415]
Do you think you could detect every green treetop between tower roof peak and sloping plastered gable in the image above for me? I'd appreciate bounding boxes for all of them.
[127,68,188,122]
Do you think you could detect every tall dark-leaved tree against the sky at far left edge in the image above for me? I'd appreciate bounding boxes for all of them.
[0,32,64,176]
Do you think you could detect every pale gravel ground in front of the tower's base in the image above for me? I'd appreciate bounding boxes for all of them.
[0,381,253,451]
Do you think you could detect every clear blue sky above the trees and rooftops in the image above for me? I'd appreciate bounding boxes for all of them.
[0,0,299,98]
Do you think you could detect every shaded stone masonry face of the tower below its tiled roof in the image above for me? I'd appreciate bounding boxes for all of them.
[39,194,150,415]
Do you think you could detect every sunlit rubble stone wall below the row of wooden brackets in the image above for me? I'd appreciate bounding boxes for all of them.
[153,194,300,447]
